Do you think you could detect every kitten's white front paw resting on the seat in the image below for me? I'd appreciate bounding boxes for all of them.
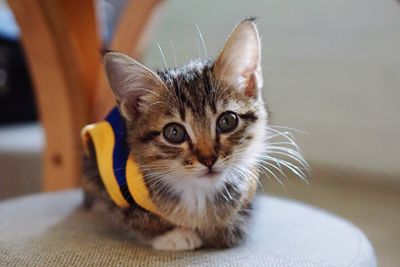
[151,228,203,251]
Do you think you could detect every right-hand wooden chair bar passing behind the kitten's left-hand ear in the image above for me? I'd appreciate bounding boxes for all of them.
[91,0,162,121]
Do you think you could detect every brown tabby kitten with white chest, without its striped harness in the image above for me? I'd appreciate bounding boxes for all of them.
[84,19,267,250]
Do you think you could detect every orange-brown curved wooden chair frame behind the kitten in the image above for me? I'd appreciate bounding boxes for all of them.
[8,0,161,191]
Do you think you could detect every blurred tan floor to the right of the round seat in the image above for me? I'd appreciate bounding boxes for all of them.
[263,168,400,267]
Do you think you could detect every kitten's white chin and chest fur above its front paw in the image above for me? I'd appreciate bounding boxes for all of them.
[155,169,250,228]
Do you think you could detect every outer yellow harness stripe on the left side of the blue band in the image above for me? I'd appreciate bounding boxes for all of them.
[82,121,129,207]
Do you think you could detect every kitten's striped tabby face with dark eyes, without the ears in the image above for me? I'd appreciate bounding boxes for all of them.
[129,62,266,189]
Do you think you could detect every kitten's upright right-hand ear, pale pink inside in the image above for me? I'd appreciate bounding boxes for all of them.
[214,19,263,97]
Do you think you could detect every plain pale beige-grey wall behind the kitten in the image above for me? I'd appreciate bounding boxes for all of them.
[146,0,400,179]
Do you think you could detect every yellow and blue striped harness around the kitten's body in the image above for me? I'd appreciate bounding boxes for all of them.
[82,107,160,215]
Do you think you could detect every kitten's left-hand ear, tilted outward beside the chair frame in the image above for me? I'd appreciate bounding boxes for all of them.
[104,52,165,120]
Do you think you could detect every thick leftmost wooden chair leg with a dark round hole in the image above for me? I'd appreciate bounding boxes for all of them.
[8,0,98,191]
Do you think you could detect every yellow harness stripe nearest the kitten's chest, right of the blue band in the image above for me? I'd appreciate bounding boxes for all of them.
[126,158,162,217]
